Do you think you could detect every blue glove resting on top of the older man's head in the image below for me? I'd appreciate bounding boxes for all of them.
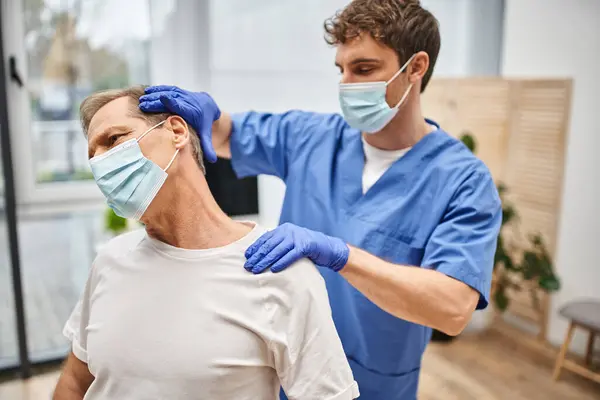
[140,86,221,163]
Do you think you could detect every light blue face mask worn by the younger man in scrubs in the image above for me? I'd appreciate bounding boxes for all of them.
[339,55,415,133]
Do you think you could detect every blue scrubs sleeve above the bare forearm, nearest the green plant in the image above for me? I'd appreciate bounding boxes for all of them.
[422,171,502,310]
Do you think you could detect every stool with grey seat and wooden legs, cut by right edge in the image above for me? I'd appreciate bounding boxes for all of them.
[554,300,600,383]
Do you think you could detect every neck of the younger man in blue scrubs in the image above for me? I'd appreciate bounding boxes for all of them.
[364,94,431,150]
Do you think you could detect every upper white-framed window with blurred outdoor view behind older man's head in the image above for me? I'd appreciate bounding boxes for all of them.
[7,0,155,203]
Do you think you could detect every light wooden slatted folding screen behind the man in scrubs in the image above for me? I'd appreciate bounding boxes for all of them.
[423,78,572,337]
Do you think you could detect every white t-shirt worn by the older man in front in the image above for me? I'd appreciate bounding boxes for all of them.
[64,223,359,400]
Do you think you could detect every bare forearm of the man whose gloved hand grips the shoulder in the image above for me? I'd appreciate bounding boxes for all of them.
[340,247,479,335]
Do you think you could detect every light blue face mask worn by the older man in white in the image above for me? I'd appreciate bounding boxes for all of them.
[90,121,179,220]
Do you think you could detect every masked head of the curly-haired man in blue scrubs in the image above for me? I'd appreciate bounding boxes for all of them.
[324,0,441,133]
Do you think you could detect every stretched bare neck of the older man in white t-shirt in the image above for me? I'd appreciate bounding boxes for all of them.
[142,160,251,249]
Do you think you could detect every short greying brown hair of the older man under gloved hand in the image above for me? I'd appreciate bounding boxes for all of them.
[79,85,205,173]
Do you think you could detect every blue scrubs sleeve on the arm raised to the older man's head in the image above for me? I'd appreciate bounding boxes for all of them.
[230,111,316,180]
